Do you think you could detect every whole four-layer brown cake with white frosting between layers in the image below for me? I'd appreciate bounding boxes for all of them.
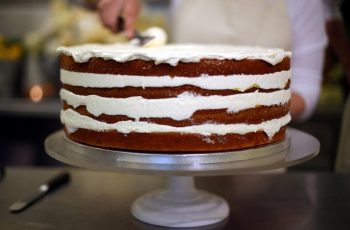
[58,44,291,153]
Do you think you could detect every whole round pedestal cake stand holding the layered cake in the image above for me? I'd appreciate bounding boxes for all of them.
[45,128,320,227]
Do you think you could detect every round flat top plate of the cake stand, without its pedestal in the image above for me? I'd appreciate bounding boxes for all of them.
[45,128,320,176]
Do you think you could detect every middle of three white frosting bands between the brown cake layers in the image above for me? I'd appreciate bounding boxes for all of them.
[60,89,291,120]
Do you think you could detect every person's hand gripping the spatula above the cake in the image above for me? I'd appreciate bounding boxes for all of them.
[97,0,140,38]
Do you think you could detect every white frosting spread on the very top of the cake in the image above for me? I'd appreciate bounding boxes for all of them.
[57,43,291,66]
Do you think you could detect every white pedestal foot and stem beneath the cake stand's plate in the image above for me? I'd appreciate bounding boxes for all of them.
[131,176,229,227]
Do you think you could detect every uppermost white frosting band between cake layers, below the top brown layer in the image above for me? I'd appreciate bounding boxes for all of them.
[61,69,290,91]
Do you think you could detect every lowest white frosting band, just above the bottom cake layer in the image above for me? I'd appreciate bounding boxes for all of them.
[61,109,291,138]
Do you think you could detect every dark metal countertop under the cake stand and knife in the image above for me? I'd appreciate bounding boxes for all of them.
[0,168,350,230]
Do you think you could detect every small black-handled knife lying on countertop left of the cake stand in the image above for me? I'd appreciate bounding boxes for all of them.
[10,172,70,213]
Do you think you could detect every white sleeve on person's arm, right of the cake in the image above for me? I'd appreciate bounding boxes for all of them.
[286,0,327,120]
